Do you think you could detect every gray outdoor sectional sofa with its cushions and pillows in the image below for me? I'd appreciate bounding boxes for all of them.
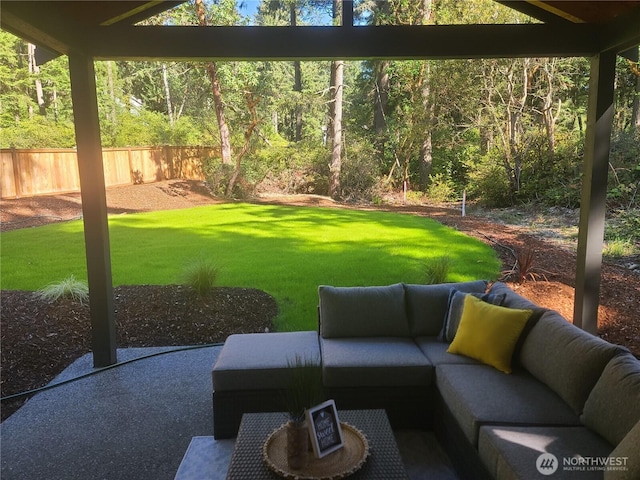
[212,281,640,479]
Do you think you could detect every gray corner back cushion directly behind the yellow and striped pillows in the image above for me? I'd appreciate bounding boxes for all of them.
[404,280,487,337]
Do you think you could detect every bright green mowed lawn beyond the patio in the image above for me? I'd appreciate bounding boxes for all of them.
[0,203,500,331]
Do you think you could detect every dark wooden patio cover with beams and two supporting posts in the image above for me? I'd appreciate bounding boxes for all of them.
[0,0,640,367]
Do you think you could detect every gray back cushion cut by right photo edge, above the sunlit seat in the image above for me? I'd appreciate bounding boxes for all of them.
[580,353,640,450]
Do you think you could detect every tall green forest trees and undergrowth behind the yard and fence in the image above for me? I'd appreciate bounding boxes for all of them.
[0,0,640,253]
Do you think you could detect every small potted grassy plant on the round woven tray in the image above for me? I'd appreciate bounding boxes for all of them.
[285,356,323,470]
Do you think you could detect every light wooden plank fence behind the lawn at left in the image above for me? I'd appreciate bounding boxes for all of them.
[0,146,218,198]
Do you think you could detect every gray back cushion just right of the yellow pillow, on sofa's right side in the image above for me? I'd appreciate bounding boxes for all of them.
[520,311,624,414]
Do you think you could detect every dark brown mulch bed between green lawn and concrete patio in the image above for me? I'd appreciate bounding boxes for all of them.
[0,285,278,420]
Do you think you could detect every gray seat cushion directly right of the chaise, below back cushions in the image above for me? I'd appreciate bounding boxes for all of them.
[320,337,433,387]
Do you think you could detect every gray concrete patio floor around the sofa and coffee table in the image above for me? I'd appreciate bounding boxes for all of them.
[0,347,457,480]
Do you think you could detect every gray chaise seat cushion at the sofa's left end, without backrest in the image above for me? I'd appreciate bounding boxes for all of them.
[211,331,320,391]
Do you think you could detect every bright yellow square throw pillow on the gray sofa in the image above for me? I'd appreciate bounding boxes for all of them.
[447,295,533,373]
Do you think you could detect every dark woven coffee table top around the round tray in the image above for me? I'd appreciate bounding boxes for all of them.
[227,410,408,480]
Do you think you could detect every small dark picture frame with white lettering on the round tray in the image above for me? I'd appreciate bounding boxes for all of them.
[305,400,344,458]
